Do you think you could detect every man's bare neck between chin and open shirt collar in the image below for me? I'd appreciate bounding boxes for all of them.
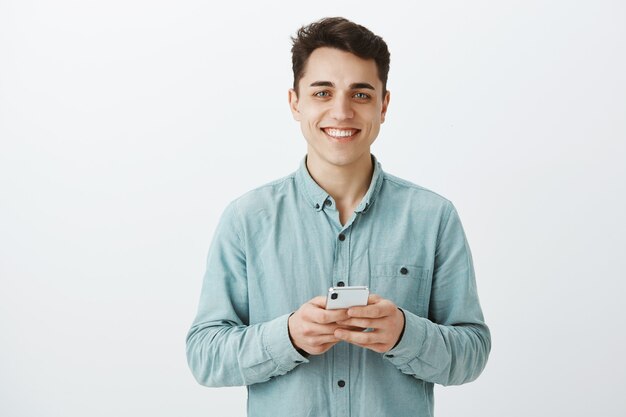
[306,153,374,207]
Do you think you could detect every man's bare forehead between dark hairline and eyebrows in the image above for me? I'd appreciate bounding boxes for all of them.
[300,47,382,89]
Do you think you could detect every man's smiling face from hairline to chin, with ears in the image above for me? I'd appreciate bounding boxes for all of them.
[289,47,389,171]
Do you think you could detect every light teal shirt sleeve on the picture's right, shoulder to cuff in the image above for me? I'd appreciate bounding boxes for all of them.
[384,204,491,385]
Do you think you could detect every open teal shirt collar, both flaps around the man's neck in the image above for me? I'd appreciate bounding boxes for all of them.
[296,155,383,213]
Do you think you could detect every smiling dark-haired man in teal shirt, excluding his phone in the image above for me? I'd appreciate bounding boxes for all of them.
[187,18,491,417]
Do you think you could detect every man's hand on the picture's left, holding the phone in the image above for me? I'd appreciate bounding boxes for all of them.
[287,296,349,355]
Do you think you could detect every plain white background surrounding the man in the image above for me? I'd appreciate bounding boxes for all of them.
[0,0,626,417]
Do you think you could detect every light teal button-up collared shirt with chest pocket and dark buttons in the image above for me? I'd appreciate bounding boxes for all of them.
[187,156,491,417]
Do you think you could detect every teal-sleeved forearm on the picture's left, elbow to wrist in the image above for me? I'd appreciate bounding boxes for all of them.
[187,314,308,387]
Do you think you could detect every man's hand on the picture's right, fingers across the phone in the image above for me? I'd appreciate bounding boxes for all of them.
[334,294,404,353]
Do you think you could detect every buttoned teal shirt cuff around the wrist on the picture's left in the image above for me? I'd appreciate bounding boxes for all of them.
[263,314,309,372]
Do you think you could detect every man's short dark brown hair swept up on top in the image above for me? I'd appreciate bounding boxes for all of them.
[291,17,389,98]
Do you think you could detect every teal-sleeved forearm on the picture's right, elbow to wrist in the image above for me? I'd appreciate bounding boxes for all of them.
[385,311,491,385]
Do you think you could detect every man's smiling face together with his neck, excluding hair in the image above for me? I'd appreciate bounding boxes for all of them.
[289,44,389,228]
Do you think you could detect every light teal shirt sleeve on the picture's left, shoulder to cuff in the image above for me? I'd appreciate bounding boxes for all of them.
[187,202,308,387]
